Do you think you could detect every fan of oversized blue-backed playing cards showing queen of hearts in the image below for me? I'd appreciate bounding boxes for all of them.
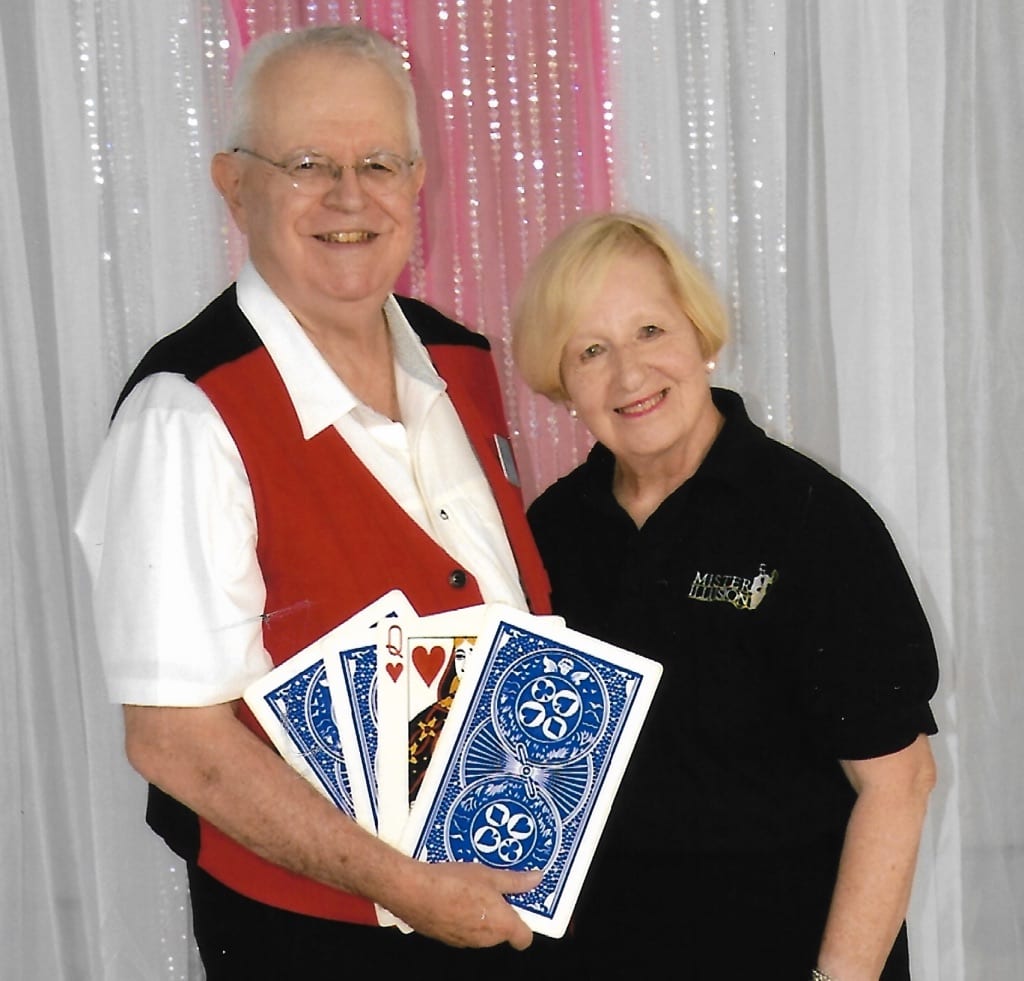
[245,591,662,937]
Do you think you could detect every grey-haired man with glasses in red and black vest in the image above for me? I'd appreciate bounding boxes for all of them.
[77,27,561,978]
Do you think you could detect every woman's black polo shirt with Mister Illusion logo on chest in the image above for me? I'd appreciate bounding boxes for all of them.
[529,389,938,855]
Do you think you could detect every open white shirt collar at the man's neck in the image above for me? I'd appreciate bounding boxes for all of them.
[238,261,445,439]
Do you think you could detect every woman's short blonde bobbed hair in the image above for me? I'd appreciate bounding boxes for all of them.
[512,211,729,401]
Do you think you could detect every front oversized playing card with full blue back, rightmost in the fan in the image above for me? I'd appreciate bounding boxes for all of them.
[402,607,662,937]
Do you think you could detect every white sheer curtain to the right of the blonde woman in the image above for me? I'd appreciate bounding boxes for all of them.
[608,0,1024,981]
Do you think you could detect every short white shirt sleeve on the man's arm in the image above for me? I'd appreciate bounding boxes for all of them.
[75,374,271,706]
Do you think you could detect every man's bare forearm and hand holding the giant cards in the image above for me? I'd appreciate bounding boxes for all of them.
[125,703,542,950]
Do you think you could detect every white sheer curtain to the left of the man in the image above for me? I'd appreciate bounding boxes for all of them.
[0,0,226,981]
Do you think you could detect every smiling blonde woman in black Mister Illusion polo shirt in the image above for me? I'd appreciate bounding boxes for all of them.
[514,213,937,981]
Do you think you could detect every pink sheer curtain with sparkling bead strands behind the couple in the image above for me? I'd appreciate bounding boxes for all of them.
[225,0,612,499]
